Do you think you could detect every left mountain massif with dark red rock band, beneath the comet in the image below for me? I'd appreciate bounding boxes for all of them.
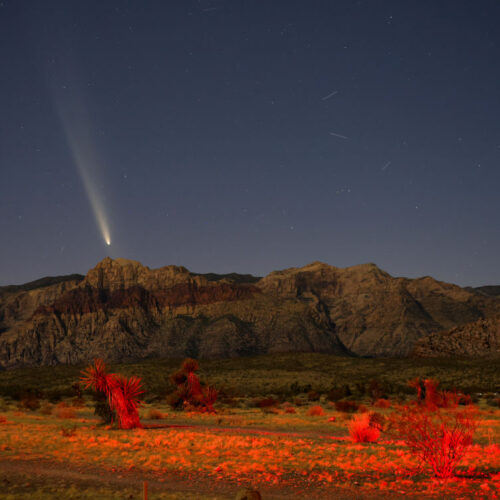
[0,258,346,367]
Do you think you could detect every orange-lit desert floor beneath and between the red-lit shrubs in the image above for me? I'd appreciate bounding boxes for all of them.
[0,355,500,499]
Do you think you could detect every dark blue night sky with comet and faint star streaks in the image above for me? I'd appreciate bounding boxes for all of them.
[0,0,500,286]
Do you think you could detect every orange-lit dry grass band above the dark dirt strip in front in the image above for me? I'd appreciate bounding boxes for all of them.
[0,407,500,498]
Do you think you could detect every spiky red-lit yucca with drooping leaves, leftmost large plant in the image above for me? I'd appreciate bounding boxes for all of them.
[81,359,144,429]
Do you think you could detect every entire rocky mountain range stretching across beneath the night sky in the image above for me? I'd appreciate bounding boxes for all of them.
[0,258,500,368]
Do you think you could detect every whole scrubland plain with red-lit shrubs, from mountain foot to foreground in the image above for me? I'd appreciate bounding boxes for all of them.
[0,355,500,499]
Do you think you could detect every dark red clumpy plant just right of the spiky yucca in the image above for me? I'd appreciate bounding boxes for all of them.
[167,358,217,413]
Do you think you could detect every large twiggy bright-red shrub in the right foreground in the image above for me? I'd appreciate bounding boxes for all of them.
[391,404,477,478]
